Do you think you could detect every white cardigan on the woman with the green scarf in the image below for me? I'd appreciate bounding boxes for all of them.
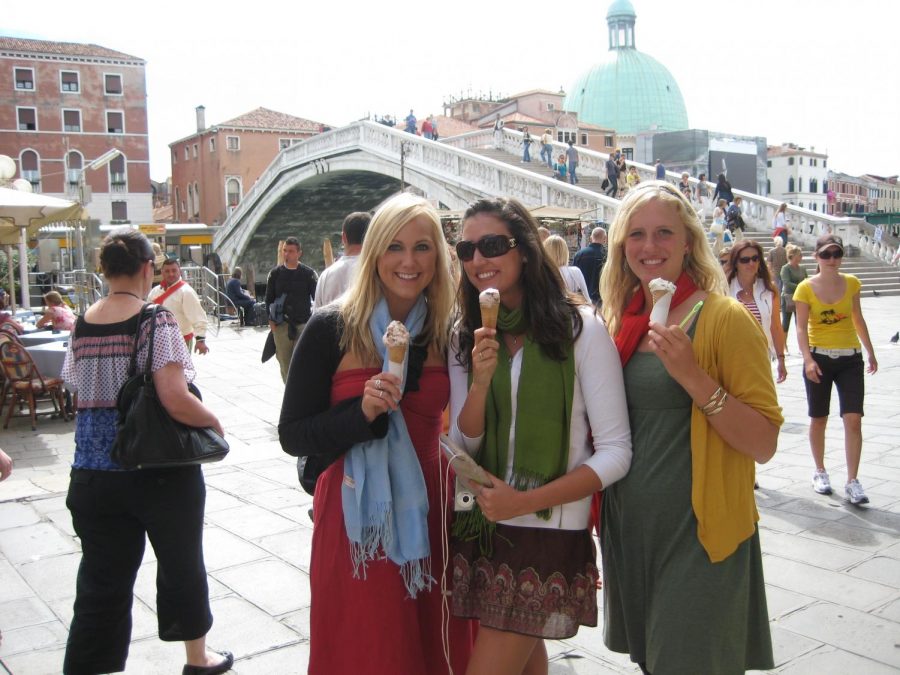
[448,307,631,530]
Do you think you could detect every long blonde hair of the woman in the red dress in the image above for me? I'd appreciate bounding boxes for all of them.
[341,192,454,363]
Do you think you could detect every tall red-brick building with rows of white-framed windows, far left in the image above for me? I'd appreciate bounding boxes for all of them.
[0,37,153,224]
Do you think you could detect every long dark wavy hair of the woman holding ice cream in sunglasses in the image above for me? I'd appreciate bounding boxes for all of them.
[457,197,585,370]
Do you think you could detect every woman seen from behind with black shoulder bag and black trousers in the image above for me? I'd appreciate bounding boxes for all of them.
[63,228,234,675]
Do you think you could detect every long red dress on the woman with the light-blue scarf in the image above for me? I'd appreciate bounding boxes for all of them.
[308,366,475,675]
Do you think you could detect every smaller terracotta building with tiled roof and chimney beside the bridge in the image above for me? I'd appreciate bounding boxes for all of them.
[169,105,327,225]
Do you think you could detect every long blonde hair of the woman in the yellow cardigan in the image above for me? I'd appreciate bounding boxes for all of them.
[600,180,726,336]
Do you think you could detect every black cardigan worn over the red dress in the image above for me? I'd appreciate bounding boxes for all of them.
[278,308,427,492]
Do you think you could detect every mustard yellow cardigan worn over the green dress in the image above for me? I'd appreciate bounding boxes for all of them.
[691,293,784,563]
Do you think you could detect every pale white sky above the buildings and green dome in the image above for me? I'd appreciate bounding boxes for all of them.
[8,0,900,180]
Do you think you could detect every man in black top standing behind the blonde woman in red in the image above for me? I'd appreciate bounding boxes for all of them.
[266,237,318,382]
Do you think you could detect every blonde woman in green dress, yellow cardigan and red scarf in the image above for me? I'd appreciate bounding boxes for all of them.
[600,181,783,674]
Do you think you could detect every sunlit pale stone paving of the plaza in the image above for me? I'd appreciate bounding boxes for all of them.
[0,297,900,675]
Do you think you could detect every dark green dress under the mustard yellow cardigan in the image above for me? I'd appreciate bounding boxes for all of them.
[601,352,774,675]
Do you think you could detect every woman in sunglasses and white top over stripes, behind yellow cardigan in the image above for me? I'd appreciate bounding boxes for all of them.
[727,239,787,383]
